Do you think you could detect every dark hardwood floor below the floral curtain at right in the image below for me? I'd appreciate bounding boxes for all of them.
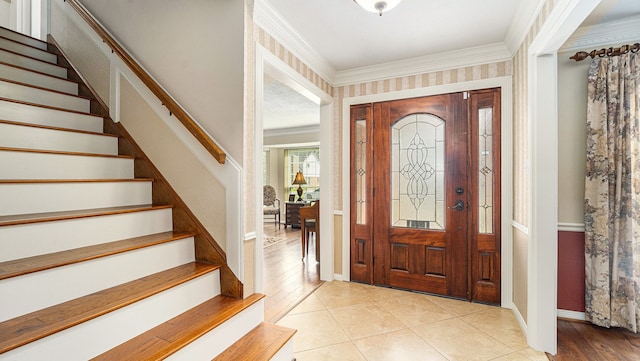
[547,320,640,361]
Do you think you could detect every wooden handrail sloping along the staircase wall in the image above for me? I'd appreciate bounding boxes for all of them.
[65,0,227,164]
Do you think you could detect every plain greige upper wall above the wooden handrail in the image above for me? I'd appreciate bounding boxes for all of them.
[77,0,244,162]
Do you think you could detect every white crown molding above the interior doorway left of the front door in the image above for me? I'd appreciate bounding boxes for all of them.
[253,0,336,83]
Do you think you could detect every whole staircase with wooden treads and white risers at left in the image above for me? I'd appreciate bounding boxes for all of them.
[0,28,294,361]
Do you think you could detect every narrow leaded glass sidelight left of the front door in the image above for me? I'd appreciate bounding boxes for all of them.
[355,119,367,224]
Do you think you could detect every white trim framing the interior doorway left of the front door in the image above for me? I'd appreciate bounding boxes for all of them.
[253,42,335,292]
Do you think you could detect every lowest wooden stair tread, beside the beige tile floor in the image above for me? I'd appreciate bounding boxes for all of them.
[213,322,296,361]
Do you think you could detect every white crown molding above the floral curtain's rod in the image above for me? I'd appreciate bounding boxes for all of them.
[558,16,640,52]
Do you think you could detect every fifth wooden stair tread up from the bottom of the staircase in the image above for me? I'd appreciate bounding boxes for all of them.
[0,204,172,227]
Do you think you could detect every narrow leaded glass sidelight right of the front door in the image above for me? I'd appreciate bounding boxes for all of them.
[478,108,494,233]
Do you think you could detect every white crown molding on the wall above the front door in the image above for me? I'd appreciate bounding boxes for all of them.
[334,43,512,86]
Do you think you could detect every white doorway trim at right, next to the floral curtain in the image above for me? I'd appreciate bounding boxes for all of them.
[527,0,601,354]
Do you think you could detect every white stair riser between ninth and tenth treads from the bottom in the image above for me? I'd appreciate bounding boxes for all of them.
[0,81,91,113]
